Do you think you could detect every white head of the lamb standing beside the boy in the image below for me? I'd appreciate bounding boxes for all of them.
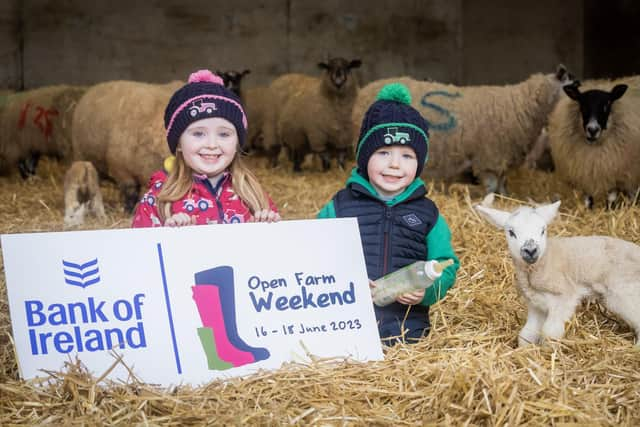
[475,201,560,264]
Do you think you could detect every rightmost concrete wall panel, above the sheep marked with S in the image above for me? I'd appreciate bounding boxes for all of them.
[462,0,583,84]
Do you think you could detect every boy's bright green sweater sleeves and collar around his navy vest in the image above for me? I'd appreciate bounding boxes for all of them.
[317,168,460,306]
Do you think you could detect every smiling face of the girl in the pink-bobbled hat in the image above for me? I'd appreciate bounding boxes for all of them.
[178,117,238,177]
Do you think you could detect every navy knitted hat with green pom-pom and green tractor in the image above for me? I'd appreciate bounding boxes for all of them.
[356,83,429,178]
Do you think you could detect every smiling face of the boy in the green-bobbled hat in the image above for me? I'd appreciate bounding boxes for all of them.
[367,145,418,197]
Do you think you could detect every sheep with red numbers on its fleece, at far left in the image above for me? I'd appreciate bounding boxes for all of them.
[0,85,86,178]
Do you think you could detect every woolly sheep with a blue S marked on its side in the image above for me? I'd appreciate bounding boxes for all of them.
[352,65,573,193]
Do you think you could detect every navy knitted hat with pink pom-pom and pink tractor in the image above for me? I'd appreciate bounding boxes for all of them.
[164,70,247,154]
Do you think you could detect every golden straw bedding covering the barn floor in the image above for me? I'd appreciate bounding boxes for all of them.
[0,158,640,426]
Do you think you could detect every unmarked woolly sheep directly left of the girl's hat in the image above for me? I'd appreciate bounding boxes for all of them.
[72,80,183,212]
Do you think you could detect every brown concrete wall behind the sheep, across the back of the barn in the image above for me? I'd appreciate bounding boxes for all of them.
[0,0,637,88]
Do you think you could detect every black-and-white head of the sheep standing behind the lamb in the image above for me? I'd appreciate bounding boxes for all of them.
[564,85,627,144]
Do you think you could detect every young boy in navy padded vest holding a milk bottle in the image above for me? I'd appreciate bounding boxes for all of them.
[318,83,460,345]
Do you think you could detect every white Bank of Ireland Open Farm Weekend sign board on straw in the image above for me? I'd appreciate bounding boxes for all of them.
[2,219,383,385]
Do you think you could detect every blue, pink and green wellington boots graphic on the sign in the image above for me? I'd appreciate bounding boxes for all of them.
[191,265,270,371]
